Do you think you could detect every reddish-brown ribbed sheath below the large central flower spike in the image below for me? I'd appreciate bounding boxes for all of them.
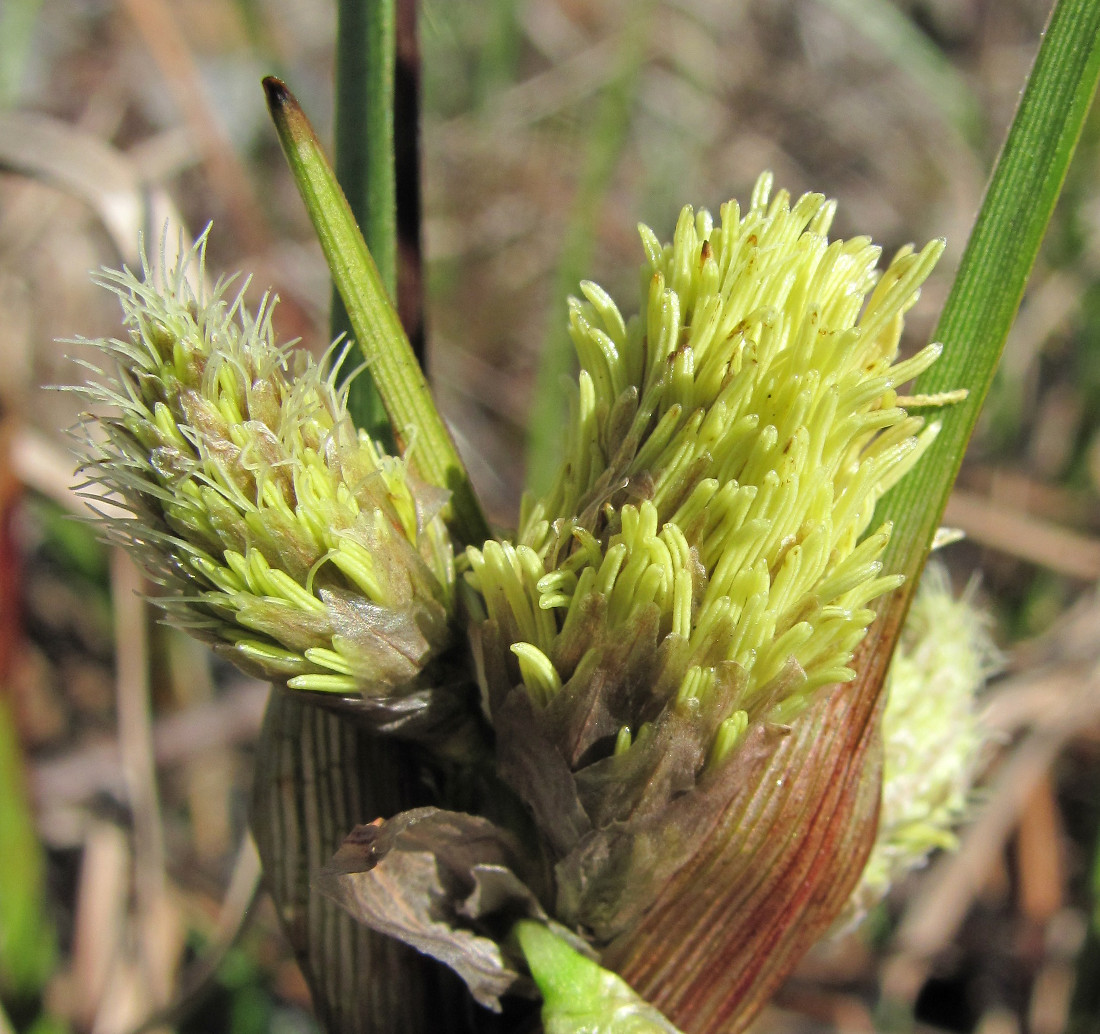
[602,636,886,1034]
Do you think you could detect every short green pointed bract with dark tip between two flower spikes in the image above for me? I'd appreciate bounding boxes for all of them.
[264,76,490,543]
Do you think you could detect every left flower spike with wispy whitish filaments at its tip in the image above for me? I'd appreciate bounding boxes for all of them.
[73,235,453,712]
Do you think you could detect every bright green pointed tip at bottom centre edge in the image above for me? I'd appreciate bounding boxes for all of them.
[515,920,680,1034]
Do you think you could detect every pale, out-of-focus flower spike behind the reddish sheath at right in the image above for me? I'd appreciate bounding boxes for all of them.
[838,564,999,927]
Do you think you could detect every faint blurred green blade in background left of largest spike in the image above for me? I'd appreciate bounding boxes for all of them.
[527,0,655,495]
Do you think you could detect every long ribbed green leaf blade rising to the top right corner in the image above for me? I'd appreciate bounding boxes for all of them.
[871,0,1100,598]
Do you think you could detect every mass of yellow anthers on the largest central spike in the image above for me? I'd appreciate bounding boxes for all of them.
[468,175,943,760]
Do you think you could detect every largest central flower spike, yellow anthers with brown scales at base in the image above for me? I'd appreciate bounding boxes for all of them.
[468,176,943,942]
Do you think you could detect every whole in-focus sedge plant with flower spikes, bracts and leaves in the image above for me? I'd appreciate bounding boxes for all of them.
[68,0,1100,1034]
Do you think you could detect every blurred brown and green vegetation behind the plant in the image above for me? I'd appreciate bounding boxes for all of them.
[0,0,1100,1034]
